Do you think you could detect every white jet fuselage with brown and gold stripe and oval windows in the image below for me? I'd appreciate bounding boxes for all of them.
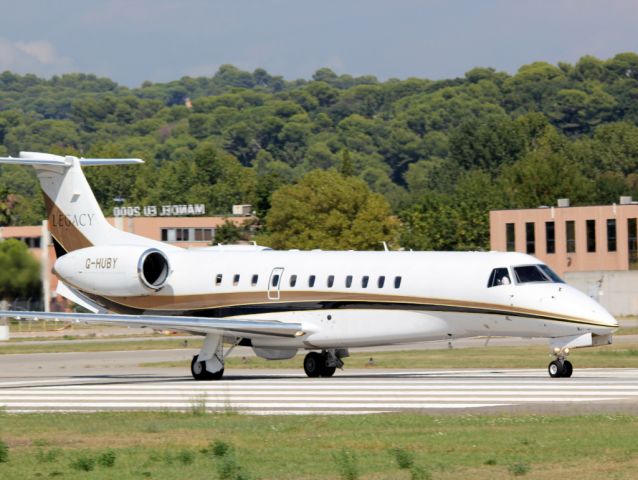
[56,247,617,348]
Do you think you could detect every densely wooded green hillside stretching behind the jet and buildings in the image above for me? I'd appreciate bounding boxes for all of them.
[0,53,638,249]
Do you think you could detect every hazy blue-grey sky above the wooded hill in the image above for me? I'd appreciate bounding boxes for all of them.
[0,0,638,87]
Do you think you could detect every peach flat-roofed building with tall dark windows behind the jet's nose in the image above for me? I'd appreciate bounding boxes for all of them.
[490,197,638,315]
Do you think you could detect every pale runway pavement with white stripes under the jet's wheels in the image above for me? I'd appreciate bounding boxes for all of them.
[0,369,638,415]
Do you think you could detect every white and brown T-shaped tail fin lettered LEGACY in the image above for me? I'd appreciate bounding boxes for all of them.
[0,152,155,252]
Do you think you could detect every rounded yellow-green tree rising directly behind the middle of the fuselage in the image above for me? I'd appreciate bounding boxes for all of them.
[260,170,397,250]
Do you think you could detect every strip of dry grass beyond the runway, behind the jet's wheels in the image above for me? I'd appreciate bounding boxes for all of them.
[141,345,638,370]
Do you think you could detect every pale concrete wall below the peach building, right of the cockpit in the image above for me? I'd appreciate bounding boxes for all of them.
[563,270,638,317]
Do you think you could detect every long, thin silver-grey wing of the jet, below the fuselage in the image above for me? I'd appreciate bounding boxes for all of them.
[0,310,305,337]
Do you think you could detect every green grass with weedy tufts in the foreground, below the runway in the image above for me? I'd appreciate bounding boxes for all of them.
[0,412,638,480]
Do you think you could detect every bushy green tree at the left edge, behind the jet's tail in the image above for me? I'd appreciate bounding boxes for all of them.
[0,238,40,301]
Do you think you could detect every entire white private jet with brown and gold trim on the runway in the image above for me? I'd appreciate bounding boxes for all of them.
[0,152,618,380]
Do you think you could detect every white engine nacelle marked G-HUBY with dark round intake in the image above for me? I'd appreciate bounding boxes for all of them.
[53,245,171,297]
